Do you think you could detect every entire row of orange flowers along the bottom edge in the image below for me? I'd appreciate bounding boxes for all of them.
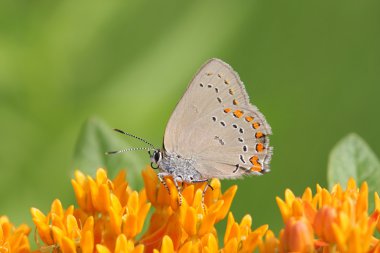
[0,168,380,253]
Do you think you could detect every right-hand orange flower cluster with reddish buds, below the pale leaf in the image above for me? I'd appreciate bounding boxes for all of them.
[260,179,380,253]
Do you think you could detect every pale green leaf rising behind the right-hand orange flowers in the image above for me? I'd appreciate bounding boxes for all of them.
[327,133,380,210]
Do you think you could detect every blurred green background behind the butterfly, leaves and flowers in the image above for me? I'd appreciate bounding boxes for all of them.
[0,0,380,234]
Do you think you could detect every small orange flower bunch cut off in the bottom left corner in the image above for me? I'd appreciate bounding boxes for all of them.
[0,216,30,253]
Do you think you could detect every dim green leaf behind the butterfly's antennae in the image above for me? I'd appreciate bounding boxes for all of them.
[73,118,148,189]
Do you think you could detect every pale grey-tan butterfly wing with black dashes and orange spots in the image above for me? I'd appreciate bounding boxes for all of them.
[164,59,272,178]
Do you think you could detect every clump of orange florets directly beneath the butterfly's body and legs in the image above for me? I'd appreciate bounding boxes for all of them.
[141,168,232,251]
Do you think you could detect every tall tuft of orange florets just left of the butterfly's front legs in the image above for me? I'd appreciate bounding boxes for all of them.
[72,169,150,246]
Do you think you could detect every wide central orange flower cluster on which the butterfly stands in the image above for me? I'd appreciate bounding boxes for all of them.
[31,168,267,253]
